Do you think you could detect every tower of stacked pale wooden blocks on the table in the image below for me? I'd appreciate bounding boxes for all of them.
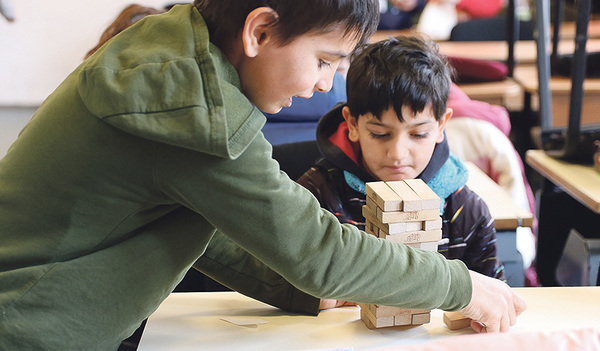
[359,179,442,329]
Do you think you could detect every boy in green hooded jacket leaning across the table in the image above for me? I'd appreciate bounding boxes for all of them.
[0,0,525,350]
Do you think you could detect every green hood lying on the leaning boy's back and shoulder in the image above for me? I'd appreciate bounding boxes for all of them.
[78,5,266,158]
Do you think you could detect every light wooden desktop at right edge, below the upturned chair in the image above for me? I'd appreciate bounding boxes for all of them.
[525,150,600,214]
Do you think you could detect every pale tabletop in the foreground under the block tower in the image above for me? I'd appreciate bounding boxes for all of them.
[138,287,600,351]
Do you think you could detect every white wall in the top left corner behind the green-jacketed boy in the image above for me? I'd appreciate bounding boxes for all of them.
[0,0,178,107]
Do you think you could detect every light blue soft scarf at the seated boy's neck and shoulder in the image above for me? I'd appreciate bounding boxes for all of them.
[344,153,469,215]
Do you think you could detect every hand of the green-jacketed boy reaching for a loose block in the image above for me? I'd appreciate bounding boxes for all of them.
[459,271,527,333]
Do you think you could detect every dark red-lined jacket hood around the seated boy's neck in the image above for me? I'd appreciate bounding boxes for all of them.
[316,103,450,183]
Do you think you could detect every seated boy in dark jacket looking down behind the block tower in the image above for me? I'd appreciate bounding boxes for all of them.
[298,37,505,280]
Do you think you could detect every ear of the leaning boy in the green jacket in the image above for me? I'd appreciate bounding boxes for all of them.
[242,7,278,57]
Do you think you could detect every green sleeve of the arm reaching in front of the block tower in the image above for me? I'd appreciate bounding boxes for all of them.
[157,135,472,310]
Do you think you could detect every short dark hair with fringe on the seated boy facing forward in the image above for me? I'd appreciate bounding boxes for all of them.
[346,36,452,121]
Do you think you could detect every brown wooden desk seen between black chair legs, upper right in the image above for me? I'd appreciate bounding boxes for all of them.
[513,66,600,127]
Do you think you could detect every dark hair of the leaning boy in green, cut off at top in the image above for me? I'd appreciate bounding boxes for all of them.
[194,0,379,47]
